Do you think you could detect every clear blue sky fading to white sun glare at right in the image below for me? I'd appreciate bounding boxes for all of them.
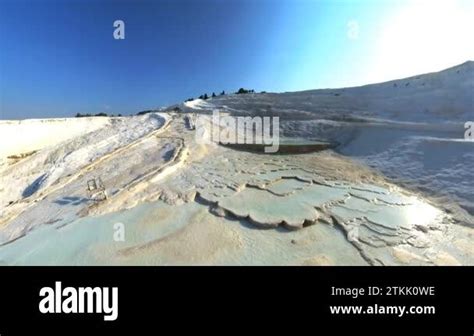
[0,0,474,119]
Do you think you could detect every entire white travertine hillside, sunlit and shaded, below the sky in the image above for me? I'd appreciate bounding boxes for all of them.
[0,62,474,265]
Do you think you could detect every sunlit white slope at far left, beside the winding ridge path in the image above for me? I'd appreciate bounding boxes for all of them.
[0,114,167,224]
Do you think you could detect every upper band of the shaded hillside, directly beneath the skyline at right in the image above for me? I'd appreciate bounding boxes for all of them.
[184,61,474,122]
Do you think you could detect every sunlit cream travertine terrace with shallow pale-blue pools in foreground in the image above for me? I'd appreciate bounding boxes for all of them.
[0,114,474,265]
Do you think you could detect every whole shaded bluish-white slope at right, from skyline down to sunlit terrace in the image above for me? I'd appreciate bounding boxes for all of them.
[183,61,474,225]
